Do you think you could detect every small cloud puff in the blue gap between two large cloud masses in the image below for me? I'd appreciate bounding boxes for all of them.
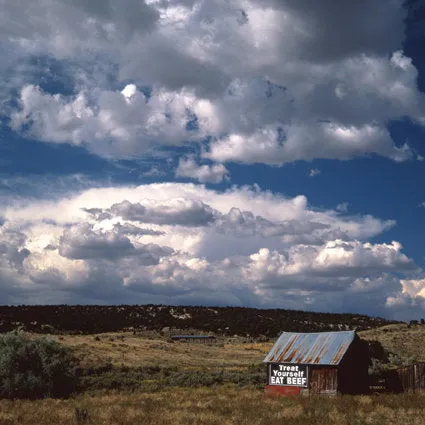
[175,158,229,183]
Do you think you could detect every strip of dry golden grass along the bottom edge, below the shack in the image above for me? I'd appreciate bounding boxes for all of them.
[0,386,425,425]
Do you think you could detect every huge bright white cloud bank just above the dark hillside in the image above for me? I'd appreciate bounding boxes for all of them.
[0,183,422,316]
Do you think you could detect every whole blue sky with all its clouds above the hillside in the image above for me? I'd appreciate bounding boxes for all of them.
[0,0,425,320]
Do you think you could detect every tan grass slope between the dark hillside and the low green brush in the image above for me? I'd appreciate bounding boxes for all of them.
[32,332,273,370]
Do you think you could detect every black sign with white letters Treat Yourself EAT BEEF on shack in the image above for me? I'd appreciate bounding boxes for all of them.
[267,363,310,388]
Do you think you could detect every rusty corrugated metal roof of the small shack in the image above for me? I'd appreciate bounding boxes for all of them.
[263,331,355,365]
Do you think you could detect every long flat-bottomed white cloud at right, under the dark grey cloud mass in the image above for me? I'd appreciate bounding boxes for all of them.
[204,122,411,165]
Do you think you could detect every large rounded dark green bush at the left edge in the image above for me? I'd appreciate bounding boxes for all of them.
[0,333,76,399]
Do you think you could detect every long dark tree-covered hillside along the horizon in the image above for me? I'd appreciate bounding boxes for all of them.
[0,305,396,338]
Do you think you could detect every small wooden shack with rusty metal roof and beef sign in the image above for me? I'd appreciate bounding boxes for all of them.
[264,331,369,395]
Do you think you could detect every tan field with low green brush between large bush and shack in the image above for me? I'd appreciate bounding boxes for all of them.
[21,332,272,393]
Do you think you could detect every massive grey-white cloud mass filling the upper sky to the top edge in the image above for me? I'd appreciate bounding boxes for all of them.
[0,0,425,164]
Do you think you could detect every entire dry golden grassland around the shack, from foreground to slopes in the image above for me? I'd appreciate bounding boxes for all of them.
[0,325,425,425]
